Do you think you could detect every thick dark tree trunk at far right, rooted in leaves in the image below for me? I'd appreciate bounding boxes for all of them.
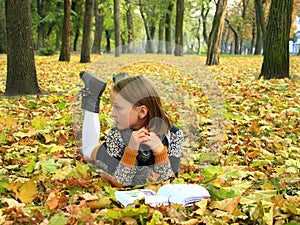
[260,0,293,79]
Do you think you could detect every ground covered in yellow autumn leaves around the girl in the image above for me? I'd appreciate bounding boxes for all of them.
[0,55,300,225]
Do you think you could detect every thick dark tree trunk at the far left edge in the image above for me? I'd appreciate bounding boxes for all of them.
[5,0,40,95]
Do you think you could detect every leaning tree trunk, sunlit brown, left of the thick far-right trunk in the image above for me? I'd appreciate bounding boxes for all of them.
[206,0,227,65]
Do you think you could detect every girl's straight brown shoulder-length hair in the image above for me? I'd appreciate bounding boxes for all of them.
[112,76,172,135]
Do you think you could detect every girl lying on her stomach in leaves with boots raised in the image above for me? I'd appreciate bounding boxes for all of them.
[81,73,183,186]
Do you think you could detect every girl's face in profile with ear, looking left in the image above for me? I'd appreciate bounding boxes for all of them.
[110,91,145,130]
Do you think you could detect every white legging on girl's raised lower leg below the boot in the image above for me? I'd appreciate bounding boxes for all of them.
[82,110,100,158]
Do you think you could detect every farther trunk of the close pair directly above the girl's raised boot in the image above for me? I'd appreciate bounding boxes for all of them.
[92,0,105,54]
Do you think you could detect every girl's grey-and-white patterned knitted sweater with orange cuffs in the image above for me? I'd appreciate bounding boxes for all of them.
[94,126,183,186]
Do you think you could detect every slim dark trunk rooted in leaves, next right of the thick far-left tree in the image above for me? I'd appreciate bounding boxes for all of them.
[59,0,72,62]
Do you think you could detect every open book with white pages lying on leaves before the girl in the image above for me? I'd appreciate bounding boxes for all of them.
[115,184,210,207]
